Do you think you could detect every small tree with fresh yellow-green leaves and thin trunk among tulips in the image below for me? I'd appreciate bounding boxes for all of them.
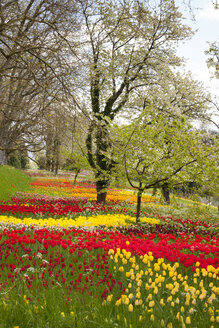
[112,107,218,221]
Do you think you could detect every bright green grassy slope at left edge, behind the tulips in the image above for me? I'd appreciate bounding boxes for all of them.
[0,165,31,200]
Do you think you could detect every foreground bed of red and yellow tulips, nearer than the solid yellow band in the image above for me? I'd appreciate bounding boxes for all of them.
[0,223,219,327]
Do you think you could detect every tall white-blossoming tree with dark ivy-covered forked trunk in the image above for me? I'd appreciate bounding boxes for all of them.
[75,0,191,202]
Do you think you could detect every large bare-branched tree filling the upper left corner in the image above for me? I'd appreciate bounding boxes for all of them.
[0,0,77,164]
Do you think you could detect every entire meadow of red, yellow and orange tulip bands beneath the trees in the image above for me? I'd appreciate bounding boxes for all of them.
[0,177,219,328]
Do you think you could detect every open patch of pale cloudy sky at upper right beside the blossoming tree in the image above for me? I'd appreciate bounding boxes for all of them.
[177,0,219,125]
